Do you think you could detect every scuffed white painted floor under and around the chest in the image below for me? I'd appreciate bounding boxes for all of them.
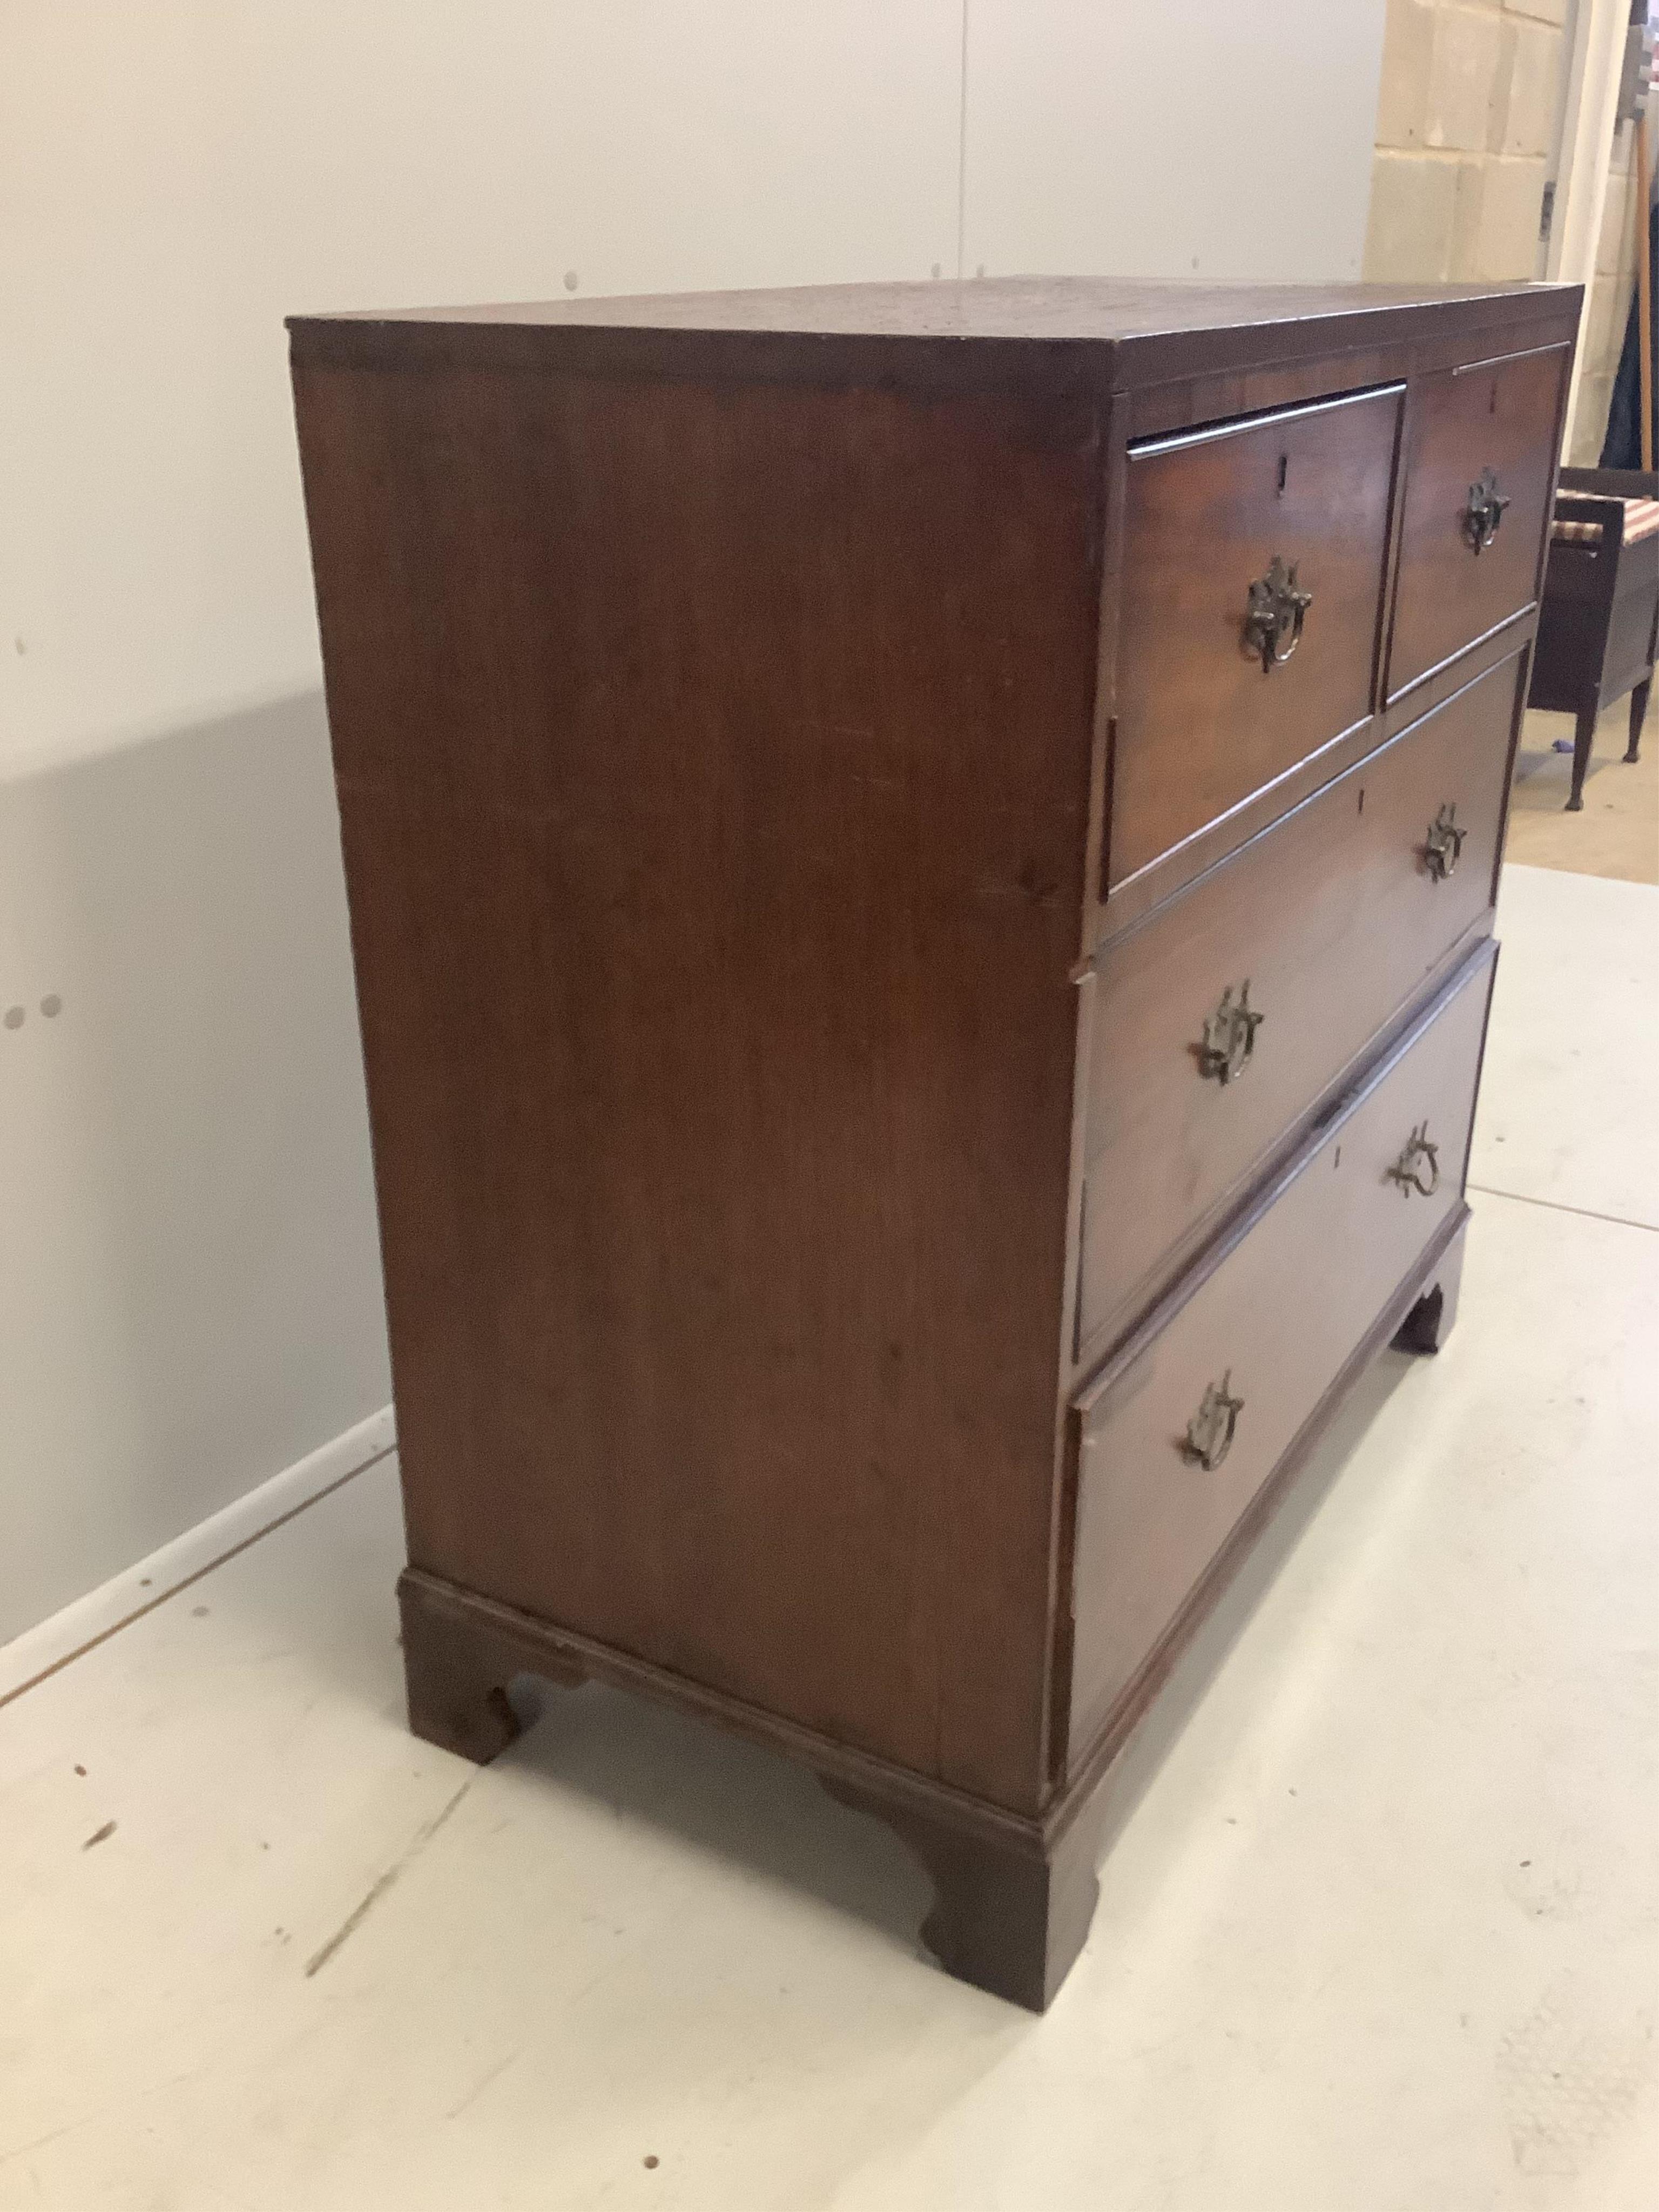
[0,869,1659,2212]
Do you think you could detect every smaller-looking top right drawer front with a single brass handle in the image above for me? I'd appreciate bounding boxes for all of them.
[1389,345,1568,699]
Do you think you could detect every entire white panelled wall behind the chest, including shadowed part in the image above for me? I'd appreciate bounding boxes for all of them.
[0,0,1382,1639]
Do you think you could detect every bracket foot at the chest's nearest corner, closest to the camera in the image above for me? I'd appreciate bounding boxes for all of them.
[819,1774,1100,2013]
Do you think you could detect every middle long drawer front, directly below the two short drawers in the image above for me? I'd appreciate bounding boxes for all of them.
[1077,655,1522,1350]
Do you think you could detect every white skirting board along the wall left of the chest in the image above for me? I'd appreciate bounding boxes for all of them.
[0,1405,398,1705]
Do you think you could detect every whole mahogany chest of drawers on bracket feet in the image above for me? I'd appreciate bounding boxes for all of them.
[290,279,1580,2006]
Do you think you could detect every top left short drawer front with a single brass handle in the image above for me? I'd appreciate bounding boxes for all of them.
[1106,385,1400,885]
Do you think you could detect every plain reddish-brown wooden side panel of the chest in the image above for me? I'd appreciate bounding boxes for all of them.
[296,340,1100,1805]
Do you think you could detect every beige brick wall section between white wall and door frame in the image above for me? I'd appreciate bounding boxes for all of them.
[1365,0,1566,281]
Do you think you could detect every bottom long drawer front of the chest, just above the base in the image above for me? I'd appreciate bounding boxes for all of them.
[1070,945,1493,1754]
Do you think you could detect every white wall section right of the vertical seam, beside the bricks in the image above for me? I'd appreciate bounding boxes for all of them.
[965,0,1387,283]
